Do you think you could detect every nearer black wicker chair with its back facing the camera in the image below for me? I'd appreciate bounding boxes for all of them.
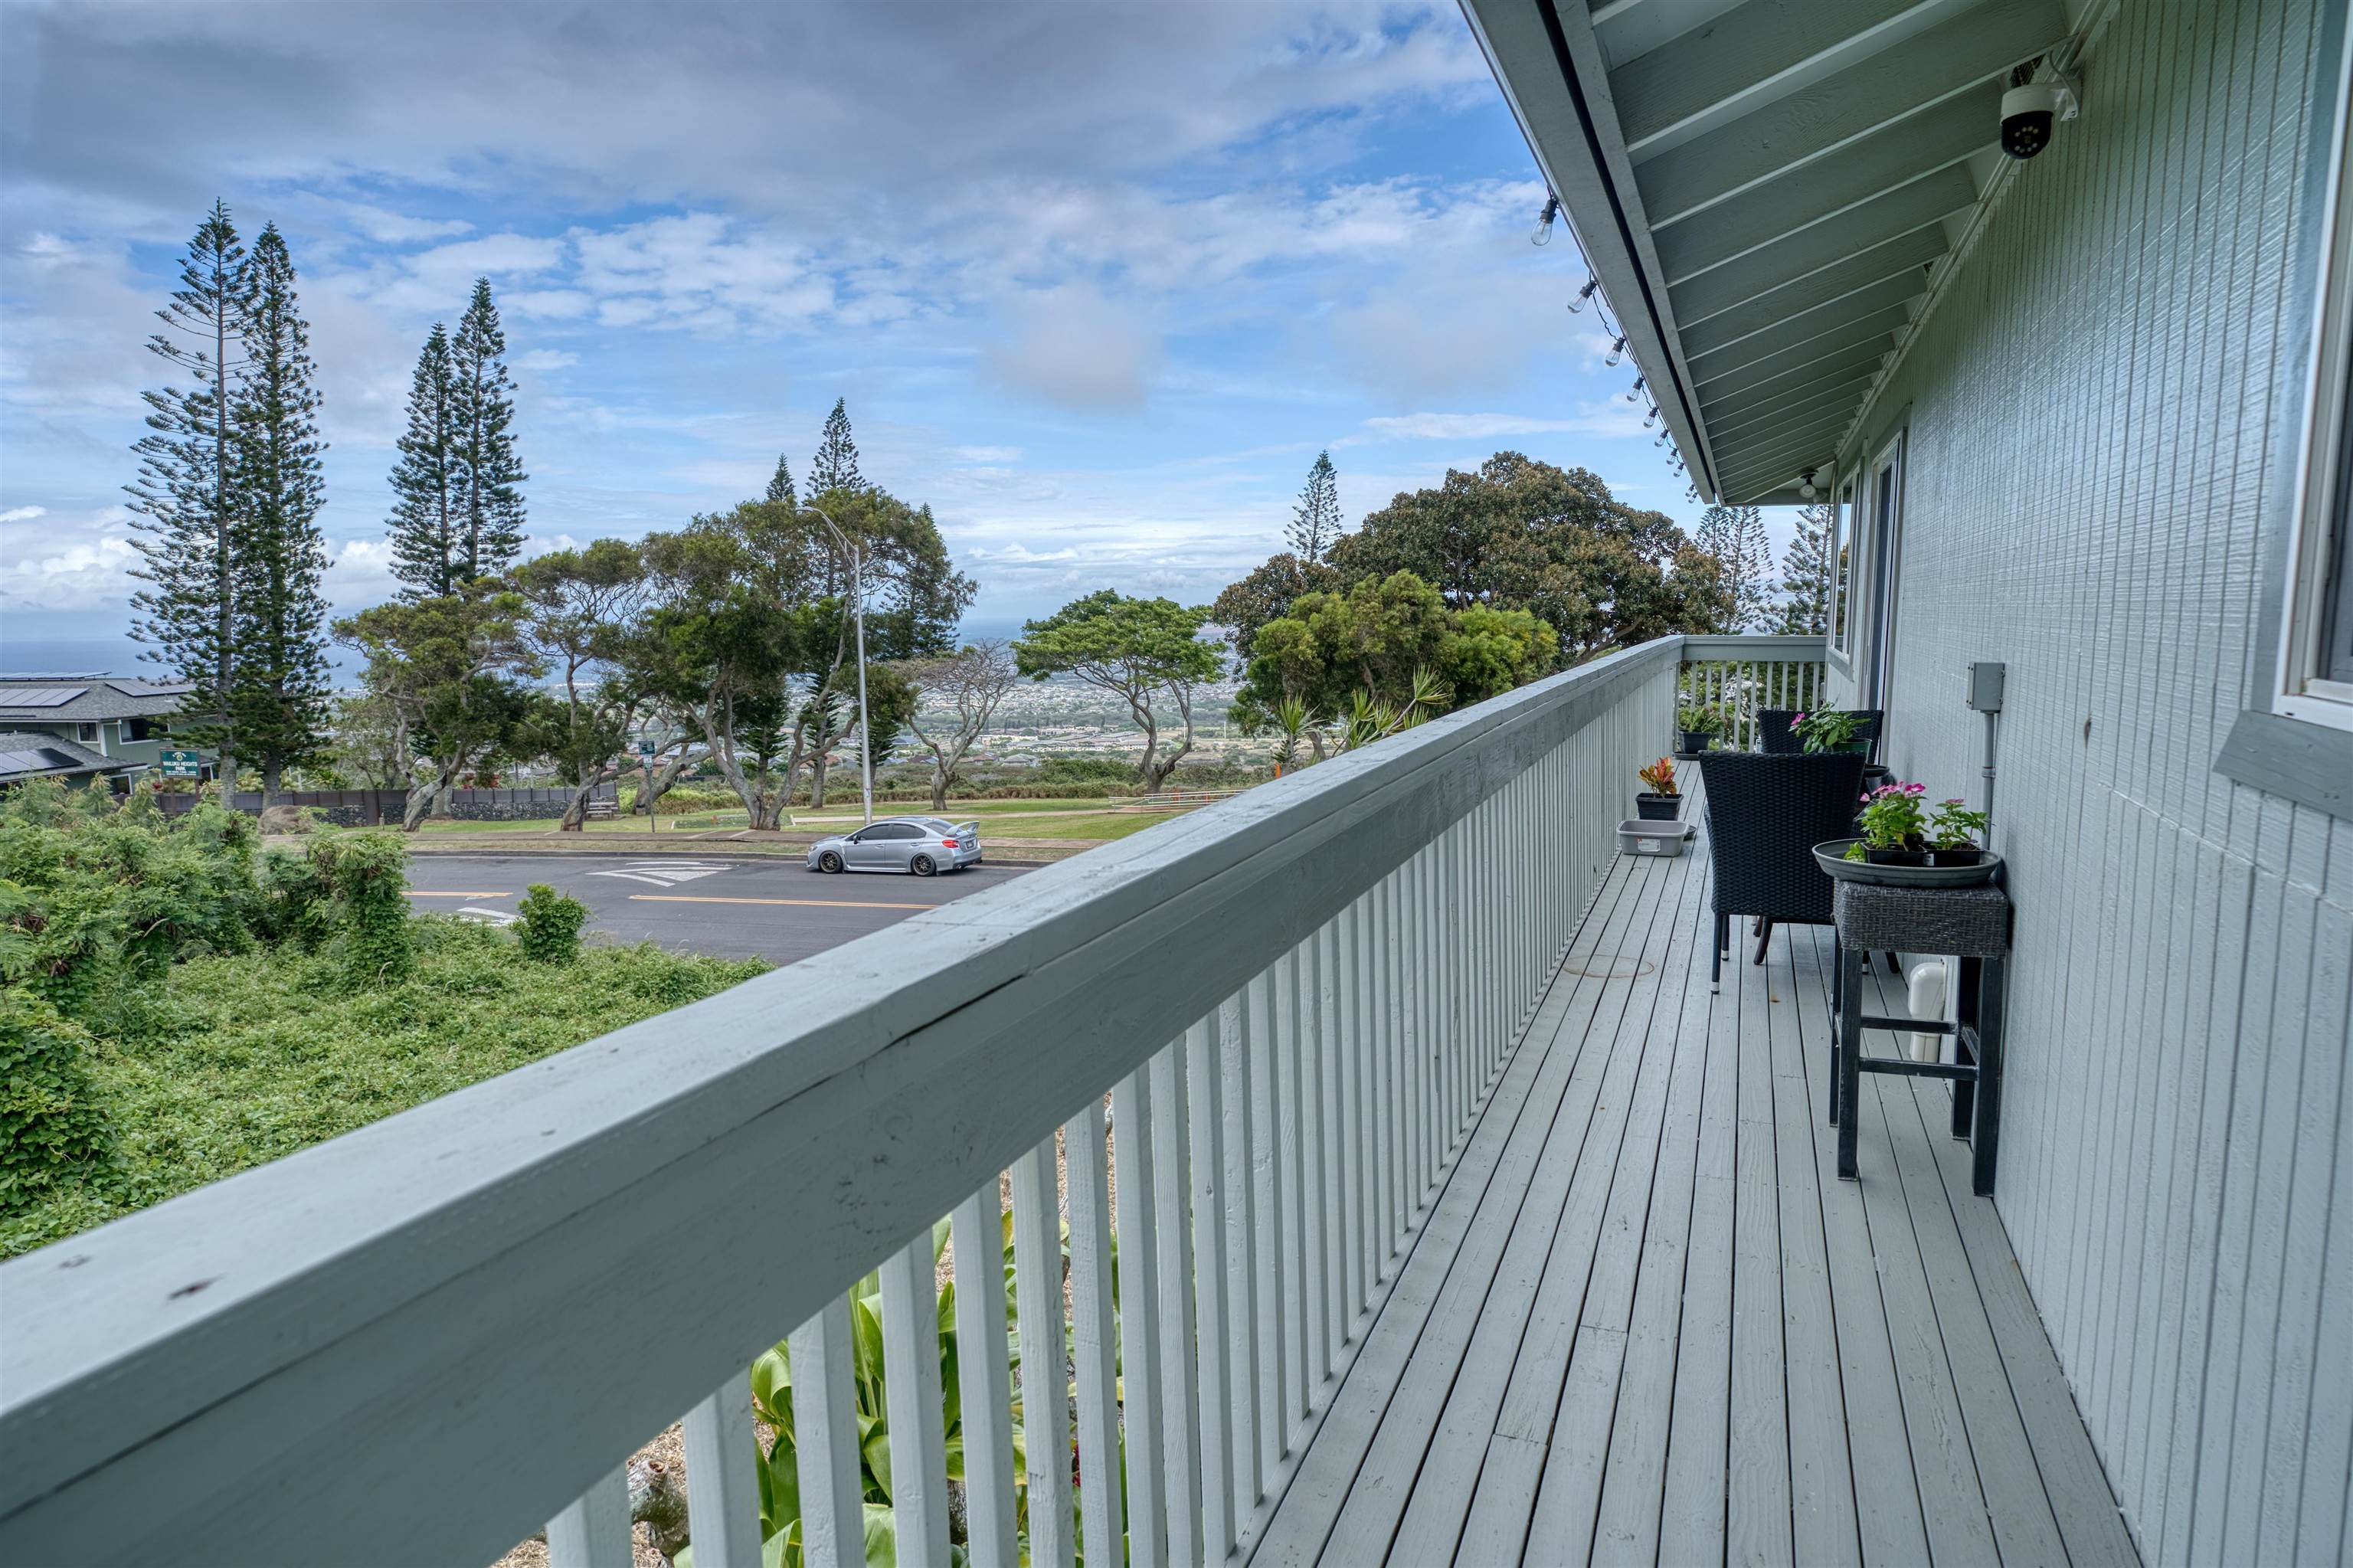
[1699,751,1864,989]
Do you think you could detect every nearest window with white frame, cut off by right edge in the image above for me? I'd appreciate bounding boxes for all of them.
[2270,13,2353,730]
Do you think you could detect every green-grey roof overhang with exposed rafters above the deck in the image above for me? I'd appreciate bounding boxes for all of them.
[1461,0,2096,506]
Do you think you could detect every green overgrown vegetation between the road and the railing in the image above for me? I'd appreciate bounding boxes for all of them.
[0,784,762,1255]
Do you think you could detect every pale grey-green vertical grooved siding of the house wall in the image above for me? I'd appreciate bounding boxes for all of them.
[1816,0,2353,1563]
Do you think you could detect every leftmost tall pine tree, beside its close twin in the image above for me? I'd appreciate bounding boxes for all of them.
[125,202,252,787]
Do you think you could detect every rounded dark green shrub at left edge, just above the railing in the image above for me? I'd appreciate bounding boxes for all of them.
[0,989,116,1217]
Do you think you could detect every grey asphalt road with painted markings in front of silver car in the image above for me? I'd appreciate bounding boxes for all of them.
[410,853,1021,963]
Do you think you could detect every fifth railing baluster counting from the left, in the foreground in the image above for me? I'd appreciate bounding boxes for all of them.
[948,1180,1019,1568]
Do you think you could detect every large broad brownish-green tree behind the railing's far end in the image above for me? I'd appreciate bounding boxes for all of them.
[1332,452,1723,662]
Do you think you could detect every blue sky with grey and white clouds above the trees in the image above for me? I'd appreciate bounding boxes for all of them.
[0,2,1731,659]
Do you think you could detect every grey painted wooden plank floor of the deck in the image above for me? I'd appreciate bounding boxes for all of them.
[1245,838,2136,1566]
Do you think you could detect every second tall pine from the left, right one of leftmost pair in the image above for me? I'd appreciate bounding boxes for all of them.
[228,224,327,796]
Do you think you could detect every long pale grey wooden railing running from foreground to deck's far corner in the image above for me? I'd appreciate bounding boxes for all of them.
[0,638,1685,1568]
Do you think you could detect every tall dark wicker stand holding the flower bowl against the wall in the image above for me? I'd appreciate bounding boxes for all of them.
[1831,883,2009,1196]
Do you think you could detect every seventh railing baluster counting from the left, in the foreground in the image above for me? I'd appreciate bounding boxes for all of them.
[1063,1095,1127,1563]
